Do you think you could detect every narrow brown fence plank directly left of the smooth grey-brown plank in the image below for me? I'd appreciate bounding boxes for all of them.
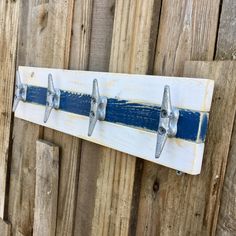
[44,0,93,236]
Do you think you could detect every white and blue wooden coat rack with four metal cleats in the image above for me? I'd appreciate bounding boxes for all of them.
[13,67,214,175]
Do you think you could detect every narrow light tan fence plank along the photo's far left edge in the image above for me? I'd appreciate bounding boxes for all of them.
[0,0,20,218]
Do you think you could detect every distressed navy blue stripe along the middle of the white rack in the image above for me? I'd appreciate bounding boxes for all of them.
[26,86,208,142]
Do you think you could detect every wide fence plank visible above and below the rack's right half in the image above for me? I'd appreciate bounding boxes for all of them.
[137,0,220,235]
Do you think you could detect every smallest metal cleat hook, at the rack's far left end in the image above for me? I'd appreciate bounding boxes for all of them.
[12,71,27,112]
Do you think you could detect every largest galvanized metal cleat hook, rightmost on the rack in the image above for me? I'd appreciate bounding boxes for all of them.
[155,85,179,158]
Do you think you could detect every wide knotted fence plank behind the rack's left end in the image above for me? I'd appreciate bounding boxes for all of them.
[8,0,74,236]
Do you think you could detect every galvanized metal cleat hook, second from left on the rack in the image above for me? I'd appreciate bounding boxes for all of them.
[43,74,61,123]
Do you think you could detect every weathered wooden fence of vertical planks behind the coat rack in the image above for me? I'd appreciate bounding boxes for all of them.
[0,0,236,236]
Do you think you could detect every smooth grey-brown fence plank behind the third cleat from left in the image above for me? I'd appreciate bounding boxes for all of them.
[74,0,115,235]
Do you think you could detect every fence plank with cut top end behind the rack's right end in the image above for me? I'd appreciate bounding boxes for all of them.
[184,61,236,235]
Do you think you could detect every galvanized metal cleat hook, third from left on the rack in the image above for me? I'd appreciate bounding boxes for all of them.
[88,79,107,136]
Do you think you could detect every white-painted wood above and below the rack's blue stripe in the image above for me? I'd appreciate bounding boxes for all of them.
[15,67,214,175]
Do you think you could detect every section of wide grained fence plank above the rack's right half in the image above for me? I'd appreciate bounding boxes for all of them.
[155,0,220,76]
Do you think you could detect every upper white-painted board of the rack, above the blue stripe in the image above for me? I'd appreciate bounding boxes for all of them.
[19,67,214,112]
